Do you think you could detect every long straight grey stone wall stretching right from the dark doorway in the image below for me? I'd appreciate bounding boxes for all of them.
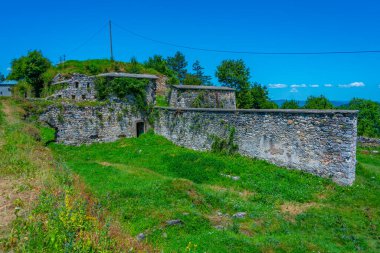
[155,108,357,185]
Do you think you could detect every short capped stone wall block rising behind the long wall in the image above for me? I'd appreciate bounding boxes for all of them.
[169,85,236,109]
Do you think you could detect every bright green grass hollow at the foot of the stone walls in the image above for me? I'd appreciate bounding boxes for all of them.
[47,131,380,252]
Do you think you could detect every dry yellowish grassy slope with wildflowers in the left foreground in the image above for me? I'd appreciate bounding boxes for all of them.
[0,97,152,252]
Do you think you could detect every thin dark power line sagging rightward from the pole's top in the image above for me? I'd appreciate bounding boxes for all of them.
[113,23,380,55]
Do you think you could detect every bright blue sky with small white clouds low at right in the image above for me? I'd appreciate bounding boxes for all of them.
[0,0,380,101]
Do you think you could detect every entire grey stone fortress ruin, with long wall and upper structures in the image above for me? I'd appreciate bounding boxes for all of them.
[40,73,357,185]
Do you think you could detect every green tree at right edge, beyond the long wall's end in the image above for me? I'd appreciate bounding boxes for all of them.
[347,98,380,137]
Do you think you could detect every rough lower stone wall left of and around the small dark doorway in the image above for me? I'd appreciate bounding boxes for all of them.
[40,102,148,145]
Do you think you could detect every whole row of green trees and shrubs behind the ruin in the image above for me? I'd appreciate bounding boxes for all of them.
[0,50,380,137]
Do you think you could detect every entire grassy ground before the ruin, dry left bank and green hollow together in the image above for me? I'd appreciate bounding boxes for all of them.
[0,99,380,252]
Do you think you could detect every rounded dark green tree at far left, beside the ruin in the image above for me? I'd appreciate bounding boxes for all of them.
[8,50,51,97]
